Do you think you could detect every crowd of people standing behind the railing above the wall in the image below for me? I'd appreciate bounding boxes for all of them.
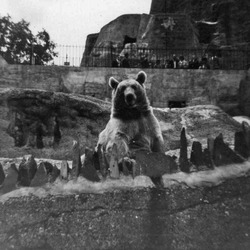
[112,53,220,69]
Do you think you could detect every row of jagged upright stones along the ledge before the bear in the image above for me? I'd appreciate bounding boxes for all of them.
[0,118,247,196]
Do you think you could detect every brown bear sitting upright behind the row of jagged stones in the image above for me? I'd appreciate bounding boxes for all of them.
[97,71,163,170]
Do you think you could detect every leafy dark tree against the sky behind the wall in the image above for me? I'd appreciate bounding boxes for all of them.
[0,15,57,65]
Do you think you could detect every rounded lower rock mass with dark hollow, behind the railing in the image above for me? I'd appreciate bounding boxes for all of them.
[81,14,198,66]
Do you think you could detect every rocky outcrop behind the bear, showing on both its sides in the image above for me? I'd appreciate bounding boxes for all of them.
[0,89,241,159]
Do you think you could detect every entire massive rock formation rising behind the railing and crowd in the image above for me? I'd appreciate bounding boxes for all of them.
[81,0,250,66]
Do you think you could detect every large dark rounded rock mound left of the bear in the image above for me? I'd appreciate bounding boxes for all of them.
[0,89,111,160]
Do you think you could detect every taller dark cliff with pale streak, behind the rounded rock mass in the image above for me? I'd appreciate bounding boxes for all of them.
[150,0,250,46]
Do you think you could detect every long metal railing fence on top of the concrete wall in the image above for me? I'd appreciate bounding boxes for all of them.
[1,44,250,70]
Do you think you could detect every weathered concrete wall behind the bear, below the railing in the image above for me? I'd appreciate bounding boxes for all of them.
[0,65,246,112]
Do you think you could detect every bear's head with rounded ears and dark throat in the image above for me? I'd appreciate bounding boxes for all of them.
[109,71,150,120]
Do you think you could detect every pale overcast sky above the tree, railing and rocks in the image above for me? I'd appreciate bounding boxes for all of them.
[0,0,151,45]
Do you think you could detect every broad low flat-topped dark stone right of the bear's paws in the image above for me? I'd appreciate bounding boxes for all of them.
[134,151,178,178]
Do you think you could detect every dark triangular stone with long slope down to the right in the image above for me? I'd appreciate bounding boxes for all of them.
[213,134,244,166]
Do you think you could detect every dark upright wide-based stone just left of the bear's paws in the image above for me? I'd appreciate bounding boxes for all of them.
[80,148,100,182]
